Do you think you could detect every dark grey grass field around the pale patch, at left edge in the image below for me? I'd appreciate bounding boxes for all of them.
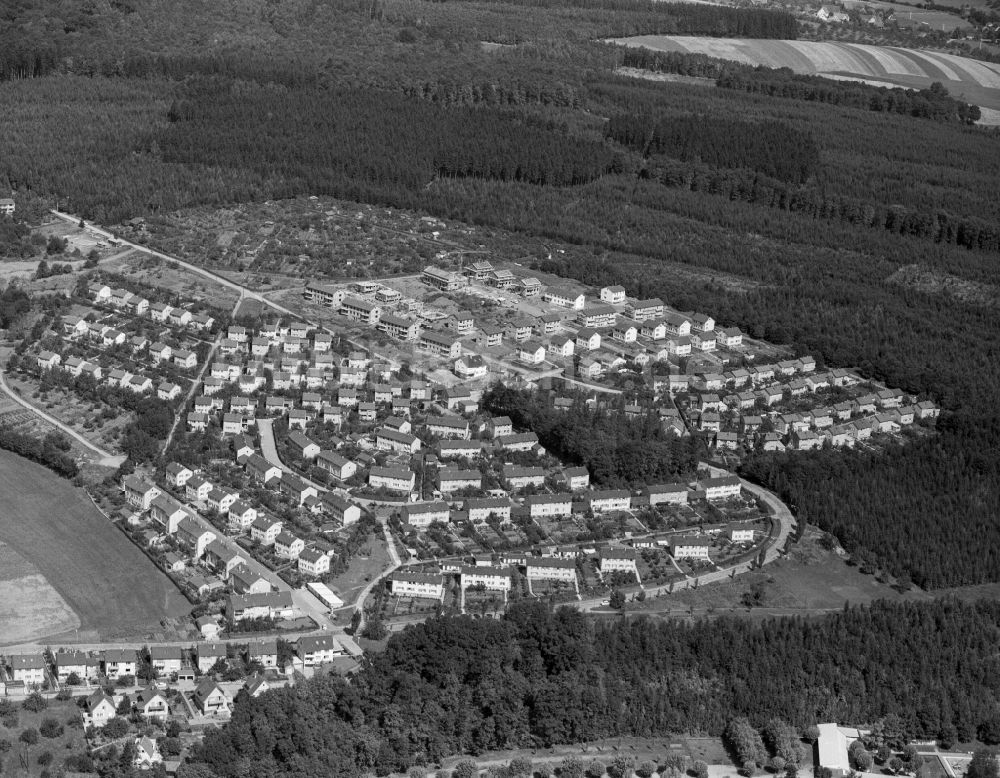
[0,451,190,644]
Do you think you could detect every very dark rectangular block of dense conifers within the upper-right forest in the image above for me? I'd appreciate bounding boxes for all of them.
[605,114,819,183]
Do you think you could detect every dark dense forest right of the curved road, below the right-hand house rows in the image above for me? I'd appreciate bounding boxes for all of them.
[743,417,1000,589]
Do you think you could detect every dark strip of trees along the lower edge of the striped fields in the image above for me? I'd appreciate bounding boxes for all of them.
[622,47,980,124]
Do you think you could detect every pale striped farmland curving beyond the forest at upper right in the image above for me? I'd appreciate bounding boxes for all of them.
[613,35,1000,109]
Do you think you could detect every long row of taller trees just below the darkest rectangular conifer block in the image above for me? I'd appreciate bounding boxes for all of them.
[641,156,1000,252]
